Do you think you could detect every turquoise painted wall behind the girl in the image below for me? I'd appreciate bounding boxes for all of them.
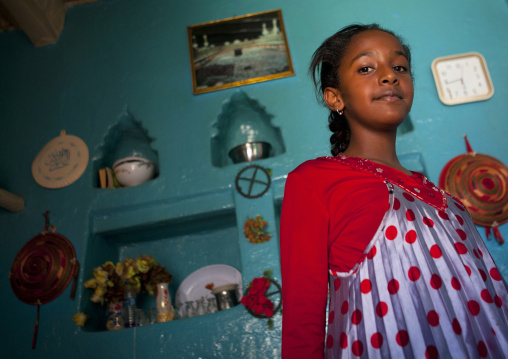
[0,0,508,358]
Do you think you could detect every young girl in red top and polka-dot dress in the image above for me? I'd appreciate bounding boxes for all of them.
[280,25,508,359]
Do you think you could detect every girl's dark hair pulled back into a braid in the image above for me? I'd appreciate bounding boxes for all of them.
[309,24,411,156]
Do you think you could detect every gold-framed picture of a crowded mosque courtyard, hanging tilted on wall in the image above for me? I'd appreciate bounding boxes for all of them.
[187,10,295,94]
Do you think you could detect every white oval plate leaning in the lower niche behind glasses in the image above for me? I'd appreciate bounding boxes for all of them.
[175,264,243,303]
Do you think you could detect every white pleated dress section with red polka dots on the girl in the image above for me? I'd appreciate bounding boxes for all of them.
[325,158,508,359]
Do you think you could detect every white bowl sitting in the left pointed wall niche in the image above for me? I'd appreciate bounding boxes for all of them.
[113,157,155,187]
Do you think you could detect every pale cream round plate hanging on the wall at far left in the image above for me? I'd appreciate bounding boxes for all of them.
[32,130,88,188]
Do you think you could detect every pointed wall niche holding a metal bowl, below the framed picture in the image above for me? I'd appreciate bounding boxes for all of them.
[211,91,286,167]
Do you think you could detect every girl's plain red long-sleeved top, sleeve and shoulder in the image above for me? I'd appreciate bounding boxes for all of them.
[280,157,438,359]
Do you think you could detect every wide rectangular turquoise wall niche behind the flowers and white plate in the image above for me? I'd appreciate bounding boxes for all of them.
[80,210,242,332]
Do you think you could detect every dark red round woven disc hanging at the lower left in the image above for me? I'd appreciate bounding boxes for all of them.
[9,232,79,305]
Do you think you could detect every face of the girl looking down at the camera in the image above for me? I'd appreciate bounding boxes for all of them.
[329,30,414,131]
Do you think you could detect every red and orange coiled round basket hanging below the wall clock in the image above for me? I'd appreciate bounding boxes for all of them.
[439,152,508,227]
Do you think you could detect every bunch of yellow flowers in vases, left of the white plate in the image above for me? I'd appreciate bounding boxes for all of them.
[84,254,172,304]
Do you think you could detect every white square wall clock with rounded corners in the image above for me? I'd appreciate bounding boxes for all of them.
[432,52,494,105]
